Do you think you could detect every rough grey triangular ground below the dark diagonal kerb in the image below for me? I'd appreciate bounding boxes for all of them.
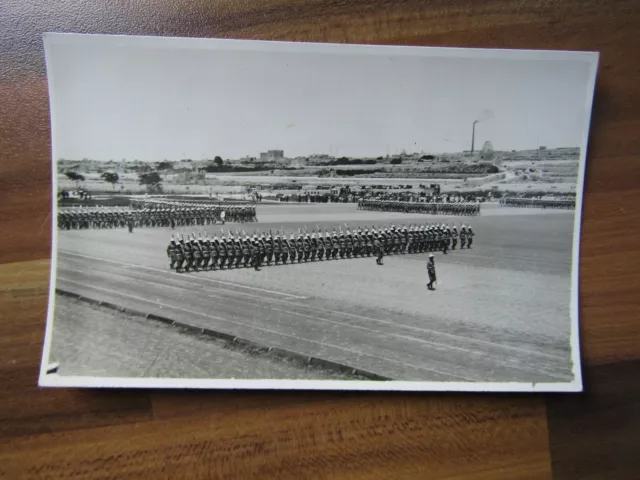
[51,295,364,380]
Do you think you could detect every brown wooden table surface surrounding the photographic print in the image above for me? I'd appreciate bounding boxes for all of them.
[0,0,640,480]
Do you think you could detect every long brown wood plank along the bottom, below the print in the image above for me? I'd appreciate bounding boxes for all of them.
[0,392,550,480]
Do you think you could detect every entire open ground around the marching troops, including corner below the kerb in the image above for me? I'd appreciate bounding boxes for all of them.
[50,204,574,382]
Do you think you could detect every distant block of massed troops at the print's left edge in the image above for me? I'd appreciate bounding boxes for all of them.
[58,204,257,231]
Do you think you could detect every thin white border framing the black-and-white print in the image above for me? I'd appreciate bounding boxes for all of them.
[38,33,599,392]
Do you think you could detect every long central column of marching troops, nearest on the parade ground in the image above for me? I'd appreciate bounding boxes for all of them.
[166,224,475,272]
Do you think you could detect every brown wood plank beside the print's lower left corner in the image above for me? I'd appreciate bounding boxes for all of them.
[0,260,151,438]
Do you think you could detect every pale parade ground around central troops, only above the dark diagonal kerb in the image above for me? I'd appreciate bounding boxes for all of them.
[54,205,573,382]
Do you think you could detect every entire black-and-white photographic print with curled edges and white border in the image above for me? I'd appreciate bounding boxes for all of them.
[39,33,598,391]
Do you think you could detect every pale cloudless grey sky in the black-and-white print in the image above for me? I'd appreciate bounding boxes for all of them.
[47,37,592,161]
